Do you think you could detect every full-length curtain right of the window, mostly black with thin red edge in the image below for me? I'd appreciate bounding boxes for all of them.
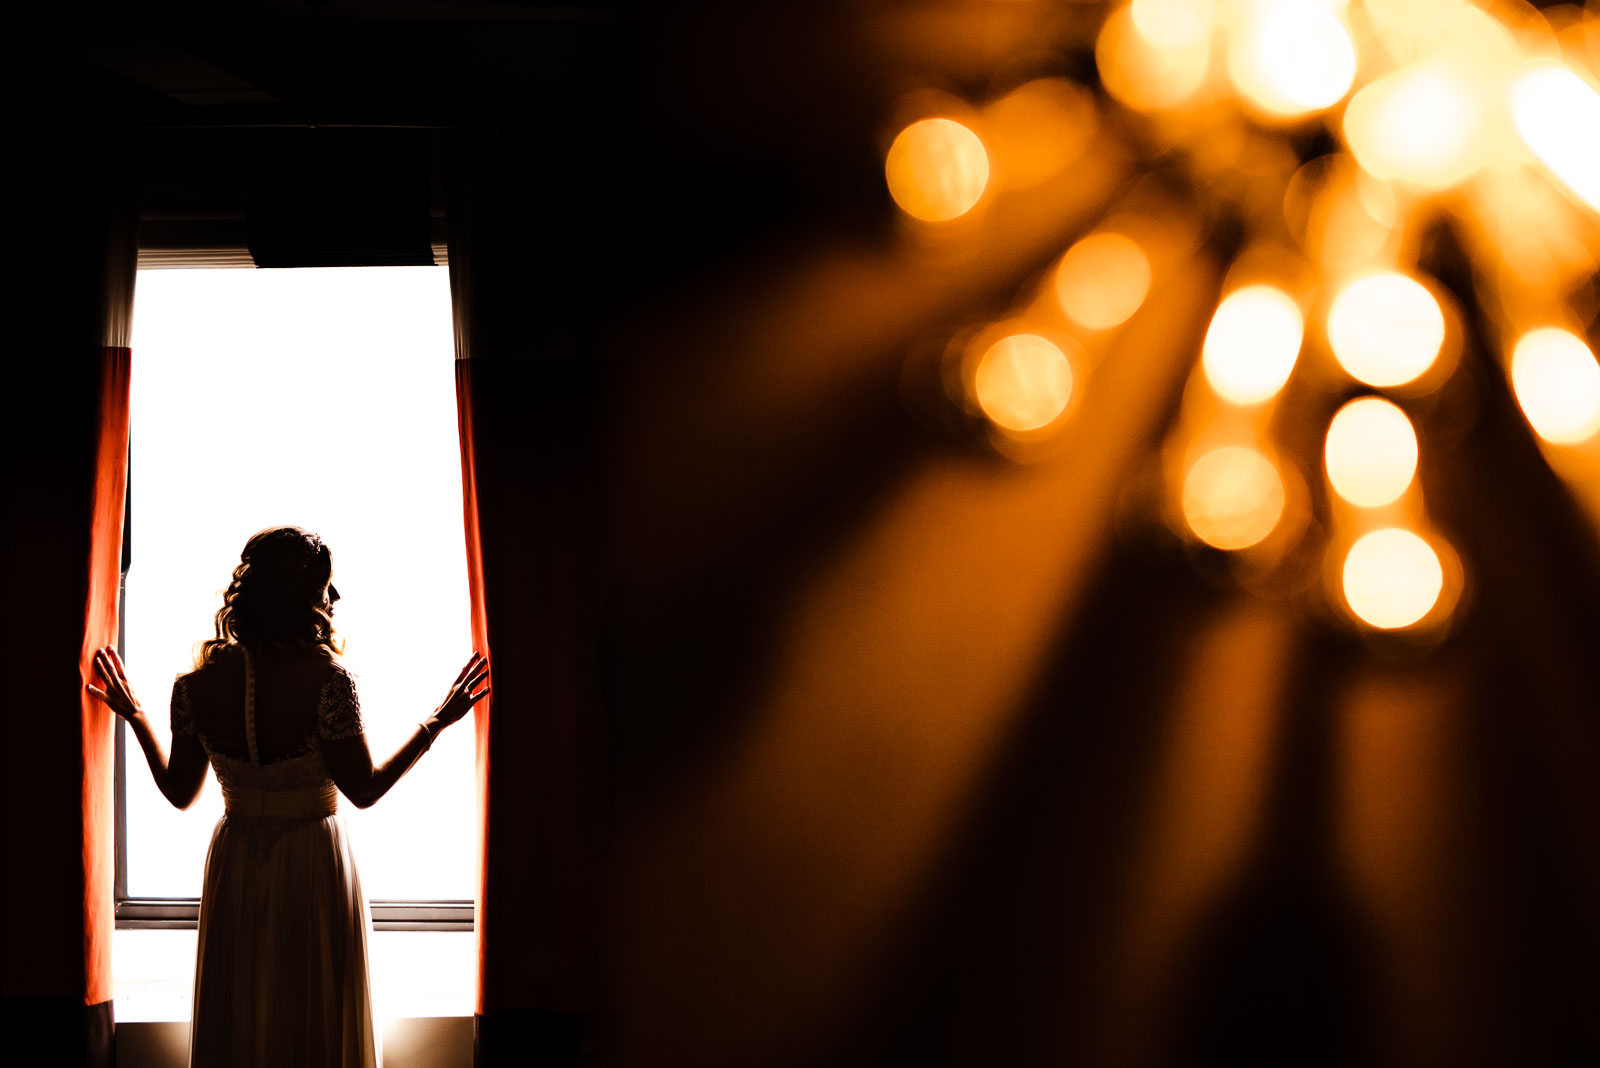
[450,131,606,1066]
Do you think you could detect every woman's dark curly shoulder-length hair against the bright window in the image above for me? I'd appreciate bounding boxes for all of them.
[195,526,344,668]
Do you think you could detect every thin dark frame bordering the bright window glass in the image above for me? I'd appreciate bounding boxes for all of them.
[112,254,477,932]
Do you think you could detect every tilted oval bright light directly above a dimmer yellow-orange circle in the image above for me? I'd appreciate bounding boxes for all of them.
[1200,286,1306,404]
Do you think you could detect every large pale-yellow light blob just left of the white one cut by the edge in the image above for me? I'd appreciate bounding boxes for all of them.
[1344,64,1483,189]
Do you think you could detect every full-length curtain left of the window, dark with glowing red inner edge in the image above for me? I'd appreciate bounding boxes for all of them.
[0,125,138,1065]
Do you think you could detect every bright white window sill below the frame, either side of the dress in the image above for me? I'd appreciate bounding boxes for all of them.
[112,927,477,1016]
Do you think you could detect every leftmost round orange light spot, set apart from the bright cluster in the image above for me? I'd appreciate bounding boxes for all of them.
[883,118,989,222]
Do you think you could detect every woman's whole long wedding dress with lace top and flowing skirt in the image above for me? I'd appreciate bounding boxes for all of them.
[173,646,379,1068]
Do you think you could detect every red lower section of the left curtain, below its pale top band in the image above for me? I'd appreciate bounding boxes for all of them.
[3,347,130,1062]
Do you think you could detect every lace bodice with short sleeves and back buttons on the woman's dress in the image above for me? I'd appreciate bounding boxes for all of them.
[171,651,363,793]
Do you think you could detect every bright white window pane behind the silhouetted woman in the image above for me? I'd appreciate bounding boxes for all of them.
[126,267,477,900]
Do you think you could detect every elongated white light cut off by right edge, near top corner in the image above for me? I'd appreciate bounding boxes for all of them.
[1510,64,1600,211]
